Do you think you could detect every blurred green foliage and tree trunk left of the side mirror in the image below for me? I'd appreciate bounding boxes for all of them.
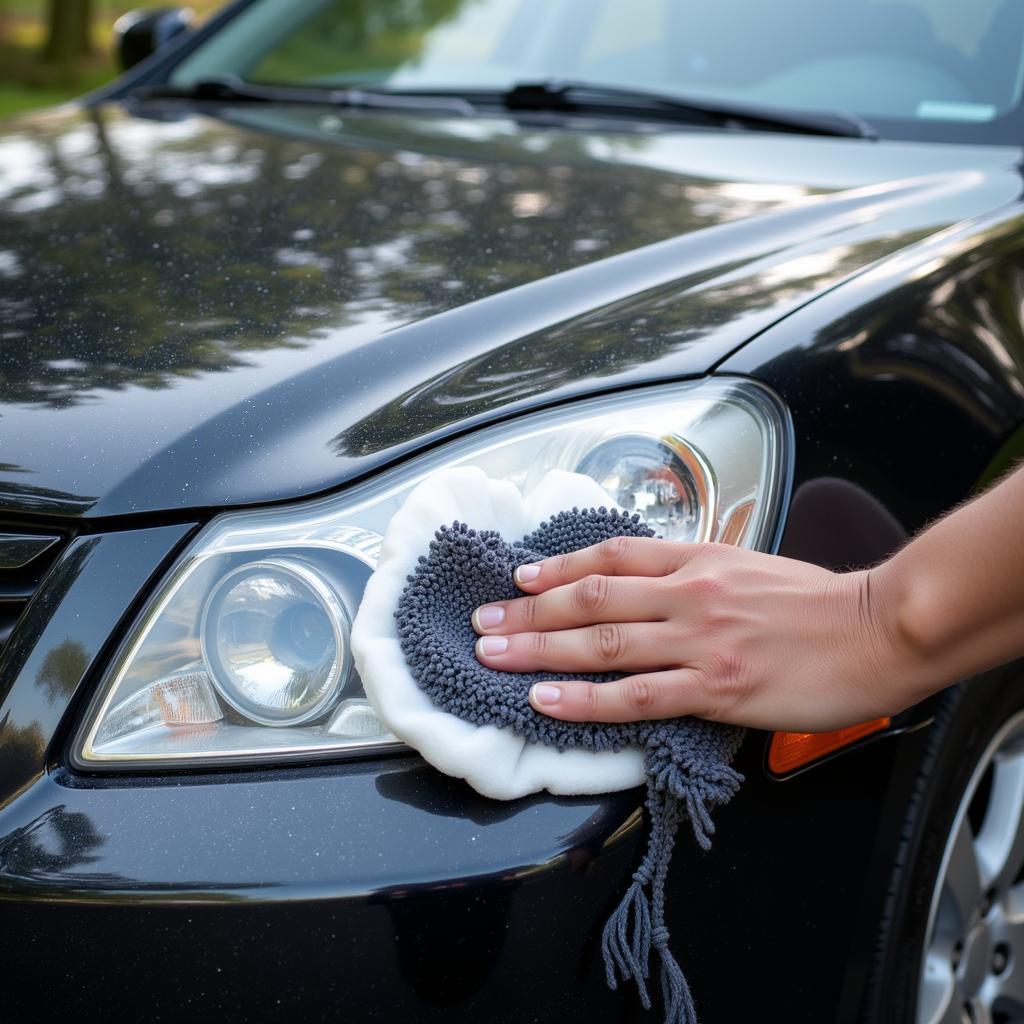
[0,0,223,117]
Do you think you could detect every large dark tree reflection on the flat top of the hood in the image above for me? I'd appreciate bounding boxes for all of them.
[0,99,774,408]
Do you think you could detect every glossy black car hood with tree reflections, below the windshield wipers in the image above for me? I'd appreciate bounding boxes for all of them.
[0,104,1021,518]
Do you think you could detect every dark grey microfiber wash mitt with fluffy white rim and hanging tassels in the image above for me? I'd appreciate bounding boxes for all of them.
[353,470,742,1024]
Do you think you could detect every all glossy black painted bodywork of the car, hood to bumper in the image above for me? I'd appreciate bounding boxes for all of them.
[6,25,1024,1024]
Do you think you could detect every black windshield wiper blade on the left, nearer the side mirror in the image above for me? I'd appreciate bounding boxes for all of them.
[130,75,476,117]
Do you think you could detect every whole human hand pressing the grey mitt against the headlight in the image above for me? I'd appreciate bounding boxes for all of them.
[473,538,924,732]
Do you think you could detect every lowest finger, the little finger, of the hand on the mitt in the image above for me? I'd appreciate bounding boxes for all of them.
[529,669,715,722]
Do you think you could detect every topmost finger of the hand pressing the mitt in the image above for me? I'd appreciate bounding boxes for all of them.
[515,537,701,594]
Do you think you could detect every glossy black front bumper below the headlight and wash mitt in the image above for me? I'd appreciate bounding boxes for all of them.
[0,716,929,1022]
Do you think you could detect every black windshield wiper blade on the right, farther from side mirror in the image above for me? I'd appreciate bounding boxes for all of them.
[500,80,879,139]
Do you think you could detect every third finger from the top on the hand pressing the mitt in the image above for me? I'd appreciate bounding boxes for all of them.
[476,623,681,673]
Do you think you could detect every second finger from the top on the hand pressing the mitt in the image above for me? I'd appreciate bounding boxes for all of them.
[472,574,671,636]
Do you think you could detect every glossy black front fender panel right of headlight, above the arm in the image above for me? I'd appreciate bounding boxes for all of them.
[720,202,1024,532]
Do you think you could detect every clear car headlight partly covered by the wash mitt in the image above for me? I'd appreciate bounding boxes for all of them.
[73,379,792,768]
